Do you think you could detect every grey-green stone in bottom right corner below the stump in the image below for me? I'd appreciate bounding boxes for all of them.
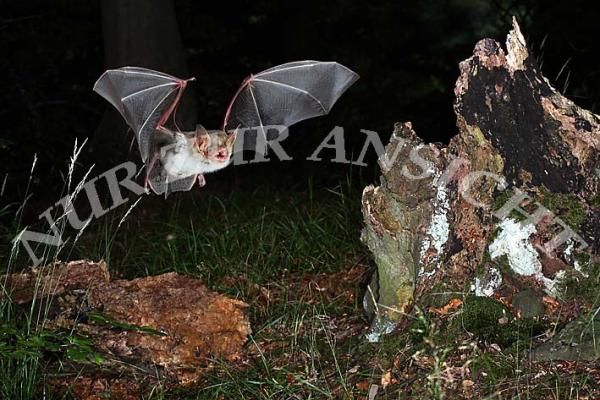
[530,314,600,361]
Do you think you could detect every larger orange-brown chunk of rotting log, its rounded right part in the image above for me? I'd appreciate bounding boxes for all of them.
[88,272,250,370]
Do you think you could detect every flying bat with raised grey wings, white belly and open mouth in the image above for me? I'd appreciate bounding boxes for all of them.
[94,61,358,195]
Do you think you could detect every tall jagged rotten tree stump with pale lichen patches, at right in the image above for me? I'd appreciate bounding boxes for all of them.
[363,21,600,340]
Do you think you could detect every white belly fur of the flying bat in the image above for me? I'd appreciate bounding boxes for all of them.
[161,145,231,178]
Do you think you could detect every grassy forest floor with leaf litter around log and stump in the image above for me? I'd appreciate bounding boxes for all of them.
[0,173,600,399]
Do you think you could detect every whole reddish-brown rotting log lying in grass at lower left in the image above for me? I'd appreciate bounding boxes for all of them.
[3,261,251,399]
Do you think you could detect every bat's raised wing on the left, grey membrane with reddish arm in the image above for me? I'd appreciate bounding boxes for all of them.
[94,67,193,162]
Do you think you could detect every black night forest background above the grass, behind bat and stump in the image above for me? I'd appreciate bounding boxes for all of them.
[0,0,600,225]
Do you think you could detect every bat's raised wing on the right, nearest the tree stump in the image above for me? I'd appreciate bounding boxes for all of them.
[223,61,358,150]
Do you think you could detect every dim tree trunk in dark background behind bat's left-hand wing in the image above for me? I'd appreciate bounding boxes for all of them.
[91,0,196,163]
